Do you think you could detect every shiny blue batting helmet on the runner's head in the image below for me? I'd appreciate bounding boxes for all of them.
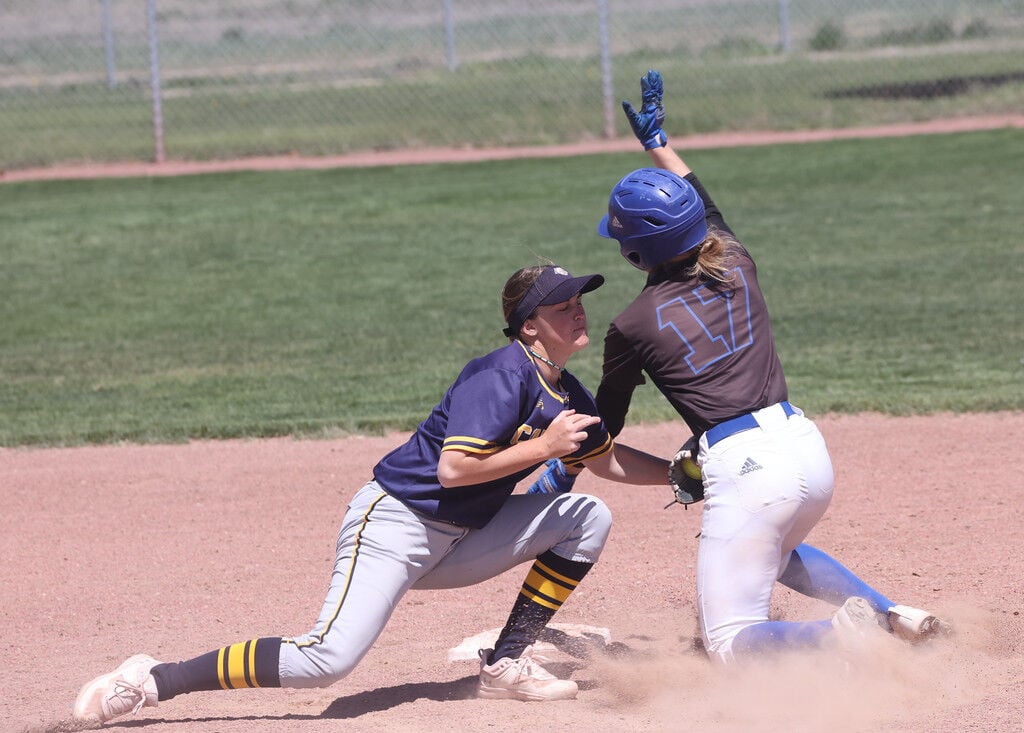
[597,168,708,270]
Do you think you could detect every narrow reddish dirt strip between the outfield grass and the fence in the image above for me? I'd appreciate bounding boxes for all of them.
[0,115,1024,183]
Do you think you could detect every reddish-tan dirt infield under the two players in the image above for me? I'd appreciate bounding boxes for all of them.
[0,414,1024,733]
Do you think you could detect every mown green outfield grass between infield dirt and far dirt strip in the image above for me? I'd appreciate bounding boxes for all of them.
[0,130,1024,445]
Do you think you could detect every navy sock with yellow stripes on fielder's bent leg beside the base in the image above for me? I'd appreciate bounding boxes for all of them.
[487,550,594,664]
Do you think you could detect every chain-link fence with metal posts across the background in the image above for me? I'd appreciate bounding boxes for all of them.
[0,0,1024,169]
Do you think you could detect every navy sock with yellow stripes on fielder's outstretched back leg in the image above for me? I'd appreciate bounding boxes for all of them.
[151,637,281,700]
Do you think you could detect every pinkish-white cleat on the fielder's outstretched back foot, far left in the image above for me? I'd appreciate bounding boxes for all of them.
[74,654,160,725]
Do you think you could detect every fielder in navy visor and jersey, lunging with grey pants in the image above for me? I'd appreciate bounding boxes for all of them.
[74,266,668,724]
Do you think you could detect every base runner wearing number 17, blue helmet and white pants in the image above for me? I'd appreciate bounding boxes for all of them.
[593,72,948,660]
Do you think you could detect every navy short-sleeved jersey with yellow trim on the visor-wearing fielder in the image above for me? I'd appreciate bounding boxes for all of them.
[374,341,611,528]
